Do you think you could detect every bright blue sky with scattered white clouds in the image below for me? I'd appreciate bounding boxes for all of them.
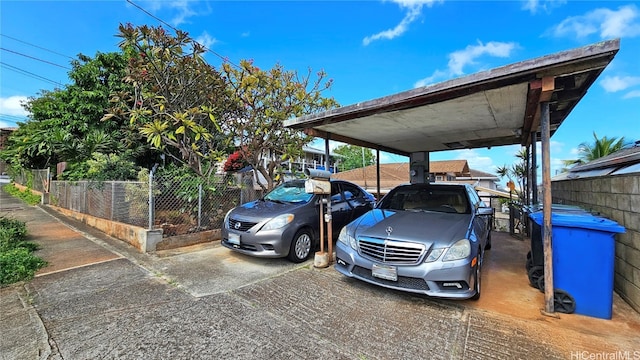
[0,0,640,184]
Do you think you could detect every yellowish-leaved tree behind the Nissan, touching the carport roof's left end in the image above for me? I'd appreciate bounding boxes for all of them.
[222,60,338,190]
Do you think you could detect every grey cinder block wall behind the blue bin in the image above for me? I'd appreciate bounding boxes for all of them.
[551,174,640,312]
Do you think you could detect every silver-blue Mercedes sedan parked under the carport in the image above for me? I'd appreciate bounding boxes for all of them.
[335,184,493,299]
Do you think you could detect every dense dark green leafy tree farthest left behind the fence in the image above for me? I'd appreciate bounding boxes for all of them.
[1,53,148,174]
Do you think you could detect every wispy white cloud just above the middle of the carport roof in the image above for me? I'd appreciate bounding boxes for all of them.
[413,41,519,88]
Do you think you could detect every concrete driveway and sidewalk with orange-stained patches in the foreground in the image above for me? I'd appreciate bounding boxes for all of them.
[0,188,640,359]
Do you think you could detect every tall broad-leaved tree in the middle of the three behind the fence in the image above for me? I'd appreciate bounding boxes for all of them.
[109,24,233,178]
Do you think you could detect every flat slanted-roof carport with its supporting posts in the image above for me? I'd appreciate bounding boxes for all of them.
[285,39,620,313]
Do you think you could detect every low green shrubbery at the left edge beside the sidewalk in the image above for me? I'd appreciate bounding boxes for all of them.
[0,217,47,286]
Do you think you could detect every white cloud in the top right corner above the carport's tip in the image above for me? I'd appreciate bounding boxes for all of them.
[548,5,640,39]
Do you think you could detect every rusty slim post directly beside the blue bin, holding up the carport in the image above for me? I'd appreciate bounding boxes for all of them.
[534,101,555,314]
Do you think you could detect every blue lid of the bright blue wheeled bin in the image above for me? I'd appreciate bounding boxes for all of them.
[529,208,625,233]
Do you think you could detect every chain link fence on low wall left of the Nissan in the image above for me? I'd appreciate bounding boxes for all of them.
[49,173,260,236]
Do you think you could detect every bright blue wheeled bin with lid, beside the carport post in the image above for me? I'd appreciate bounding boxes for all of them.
[529,209,625,319]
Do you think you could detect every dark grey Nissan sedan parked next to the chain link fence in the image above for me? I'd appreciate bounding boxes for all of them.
[221,180,375,263]
